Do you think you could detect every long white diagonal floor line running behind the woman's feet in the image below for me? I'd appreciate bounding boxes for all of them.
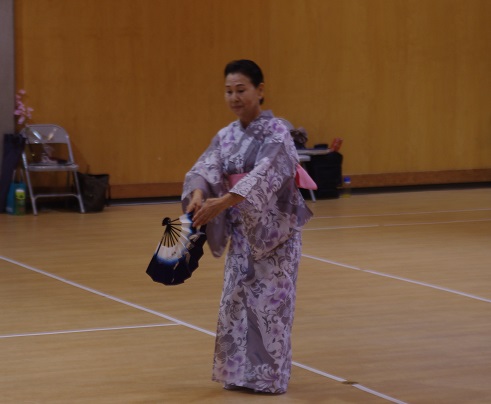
[0,256,406,404]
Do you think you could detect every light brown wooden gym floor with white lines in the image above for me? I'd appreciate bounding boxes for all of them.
[0,188,491,404]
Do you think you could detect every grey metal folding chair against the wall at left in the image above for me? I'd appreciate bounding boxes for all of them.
[21,124,85,215]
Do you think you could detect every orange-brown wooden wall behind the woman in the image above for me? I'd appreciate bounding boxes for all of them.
[15,0,491,196]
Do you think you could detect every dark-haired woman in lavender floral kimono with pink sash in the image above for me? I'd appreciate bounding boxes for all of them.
[182,60,312,394]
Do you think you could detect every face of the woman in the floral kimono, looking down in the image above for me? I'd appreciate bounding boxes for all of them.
[225,73,264,127]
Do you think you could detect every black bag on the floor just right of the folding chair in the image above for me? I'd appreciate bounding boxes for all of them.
[77,172,110,212]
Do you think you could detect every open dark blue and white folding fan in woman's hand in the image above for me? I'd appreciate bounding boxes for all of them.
[146,213,206,285]
